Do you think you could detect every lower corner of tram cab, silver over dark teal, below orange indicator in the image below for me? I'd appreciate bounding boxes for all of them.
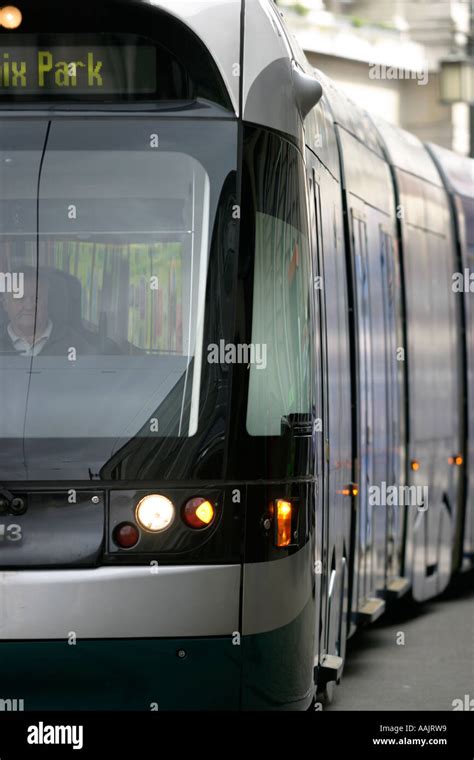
[241,536,317,710]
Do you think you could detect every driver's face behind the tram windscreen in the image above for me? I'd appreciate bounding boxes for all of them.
[4,276,48,337]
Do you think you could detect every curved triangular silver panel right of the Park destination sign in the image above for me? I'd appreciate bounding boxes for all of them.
[150,0,241,114]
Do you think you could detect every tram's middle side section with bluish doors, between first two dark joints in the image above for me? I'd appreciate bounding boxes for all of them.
[330,119,403,614]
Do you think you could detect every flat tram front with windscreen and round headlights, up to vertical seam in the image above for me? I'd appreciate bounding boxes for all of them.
[0,0,241,710]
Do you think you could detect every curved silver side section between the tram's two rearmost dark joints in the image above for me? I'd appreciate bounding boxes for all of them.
[370,121,461,599]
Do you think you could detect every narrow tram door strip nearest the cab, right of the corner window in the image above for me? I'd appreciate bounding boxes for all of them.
[309,169,334,658]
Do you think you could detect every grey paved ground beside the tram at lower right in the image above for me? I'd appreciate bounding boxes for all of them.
[326,573,474,711]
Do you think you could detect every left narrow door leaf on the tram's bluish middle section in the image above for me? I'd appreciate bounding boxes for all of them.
[352,212,374,603]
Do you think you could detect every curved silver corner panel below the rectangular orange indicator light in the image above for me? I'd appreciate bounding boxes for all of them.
[242,542,314,636]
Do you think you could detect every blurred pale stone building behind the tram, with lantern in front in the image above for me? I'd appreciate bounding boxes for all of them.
[276,0,474,155]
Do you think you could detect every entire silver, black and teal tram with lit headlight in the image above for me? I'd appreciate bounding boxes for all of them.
[0,0,474,711]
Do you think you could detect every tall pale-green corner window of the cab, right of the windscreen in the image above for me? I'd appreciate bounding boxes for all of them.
[246,138,312,436]
